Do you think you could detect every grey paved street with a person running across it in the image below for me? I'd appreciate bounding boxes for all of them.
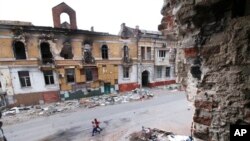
[3,90,193,141]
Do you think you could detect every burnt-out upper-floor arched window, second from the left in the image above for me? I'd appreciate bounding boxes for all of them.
[40,42,53,64]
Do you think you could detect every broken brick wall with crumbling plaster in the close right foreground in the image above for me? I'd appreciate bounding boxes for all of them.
[158,0,250,141]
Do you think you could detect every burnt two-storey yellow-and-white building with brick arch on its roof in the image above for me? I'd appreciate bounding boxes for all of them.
[0,3,175,105]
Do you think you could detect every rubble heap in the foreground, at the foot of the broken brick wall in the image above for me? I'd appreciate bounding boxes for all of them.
[129,127,193,141]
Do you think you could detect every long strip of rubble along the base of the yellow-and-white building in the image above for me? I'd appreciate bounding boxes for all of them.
[3,89,154,125]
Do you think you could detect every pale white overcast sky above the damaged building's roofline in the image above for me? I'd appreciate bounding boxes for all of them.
[0,0,163,35]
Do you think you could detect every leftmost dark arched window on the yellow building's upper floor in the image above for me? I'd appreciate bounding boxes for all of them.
[13,41,26,59]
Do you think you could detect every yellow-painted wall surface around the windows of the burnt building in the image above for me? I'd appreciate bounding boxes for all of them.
[0,26,143,91]
